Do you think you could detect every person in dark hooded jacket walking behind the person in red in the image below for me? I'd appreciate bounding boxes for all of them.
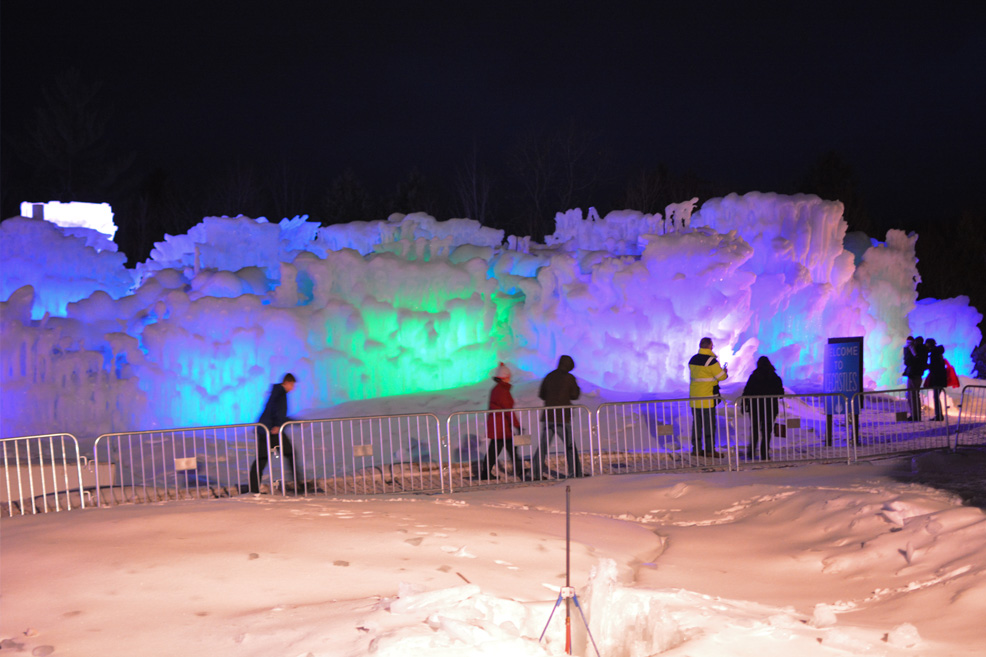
[531,355,583,479]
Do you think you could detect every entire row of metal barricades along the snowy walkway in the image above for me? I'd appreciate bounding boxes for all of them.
[13,385,986,516]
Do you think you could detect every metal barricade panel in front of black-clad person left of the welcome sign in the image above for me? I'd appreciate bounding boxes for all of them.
[732,393,853,465]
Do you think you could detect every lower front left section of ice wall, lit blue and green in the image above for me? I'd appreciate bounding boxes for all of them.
[2,250,503,435]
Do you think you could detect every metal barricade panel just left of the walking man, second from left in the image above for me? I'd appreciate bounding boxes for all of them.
[93,424,267,506]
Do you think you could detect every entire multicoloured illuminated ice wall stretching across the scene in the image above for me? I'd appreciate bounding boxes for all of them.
[0,193,982,436]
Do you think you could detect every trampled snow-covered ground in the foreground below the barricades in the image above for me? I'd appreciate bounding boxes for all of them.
[0,444,986,657]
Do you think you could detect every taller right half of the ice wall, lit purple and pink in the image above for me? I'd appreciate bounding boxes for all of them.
[512,192,980,392]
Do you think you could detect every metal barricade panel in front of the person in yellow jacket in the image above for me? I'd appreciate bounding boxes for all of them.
[596,397,730,474]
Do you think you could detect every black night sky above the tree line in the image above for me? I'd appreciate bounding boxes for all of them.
[0,0,986,231]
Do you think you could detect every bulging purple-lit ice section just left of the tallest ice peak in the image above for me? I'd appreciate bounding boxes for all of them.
[510,228,756,393]
